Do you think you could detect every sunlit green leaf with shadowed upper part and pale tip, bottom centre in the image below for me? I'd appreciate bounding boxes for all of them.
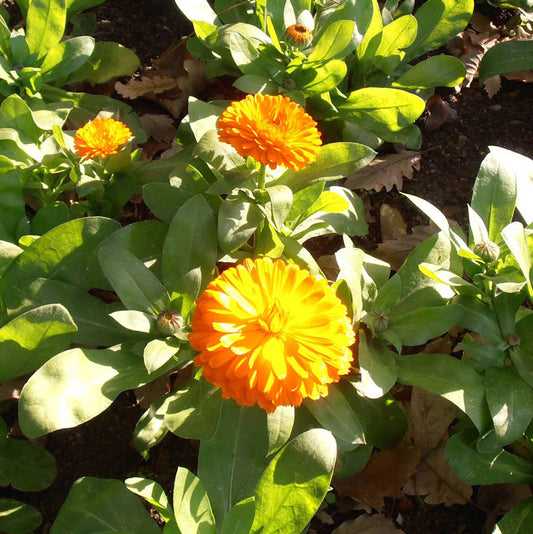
[250,428,337,534]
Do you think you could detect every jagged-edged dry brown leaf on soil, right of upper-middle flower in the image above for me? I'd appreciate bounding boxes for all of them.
[343,150,422,191]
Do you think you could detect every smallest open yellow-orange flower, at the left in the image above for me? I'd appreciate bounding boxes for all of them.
[74,117,131,158]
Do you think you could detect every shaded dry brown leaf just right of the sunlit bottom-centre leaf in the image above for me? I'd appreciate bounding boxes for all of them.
[333,444,418,508]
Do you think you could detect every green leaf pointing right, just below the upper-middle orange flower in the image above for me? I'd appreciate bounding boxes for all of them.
[270,143,376,192]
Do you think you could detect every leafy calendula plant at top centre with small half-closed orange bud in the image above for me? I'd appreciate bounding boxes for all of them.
[176,0,474,148]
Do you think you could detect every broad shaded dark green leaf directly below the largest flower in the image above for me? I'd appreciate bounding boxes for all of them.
[198,400,268,524]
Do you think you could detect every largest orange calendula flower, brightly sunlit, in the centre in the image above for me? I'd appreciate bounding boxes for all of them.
[189,258,355,412]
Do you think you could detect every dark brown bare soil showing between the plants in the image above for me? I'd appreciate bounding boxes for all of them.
[0,0,533,534]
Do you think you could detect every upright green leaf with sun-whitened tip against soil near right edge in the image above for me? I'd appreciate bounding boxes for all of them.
[472,147,520,242]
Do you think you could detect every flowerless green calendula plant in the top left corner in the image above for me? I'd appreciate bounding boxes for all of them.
[0,0,140,119]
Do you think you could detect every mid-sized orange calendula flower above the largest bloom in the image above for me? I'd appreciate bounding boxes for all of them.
[218,95,322,170]
